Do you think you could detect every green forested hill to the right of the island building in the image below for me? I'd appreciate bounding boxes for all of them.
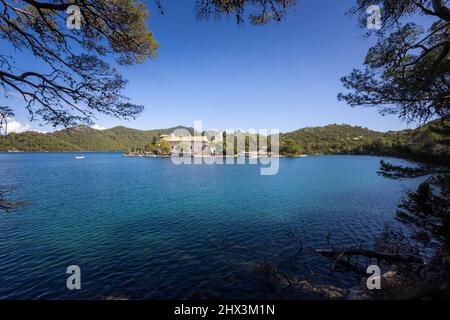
[280,120,450,165]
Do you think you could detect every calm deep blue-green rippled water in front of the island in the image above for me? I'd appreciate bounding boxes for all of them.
[0,153,418,299]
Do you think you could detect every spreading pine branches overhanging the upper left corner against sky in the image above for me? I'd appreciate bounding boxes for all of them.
[0,0,158,126]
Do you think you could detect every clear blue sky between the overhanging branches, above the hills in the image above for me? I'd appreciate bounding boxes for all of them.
[2,0,422,132]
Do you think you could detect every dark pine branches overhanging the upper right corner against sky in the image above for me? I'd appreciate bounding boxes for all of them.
[338,0,450,122]
